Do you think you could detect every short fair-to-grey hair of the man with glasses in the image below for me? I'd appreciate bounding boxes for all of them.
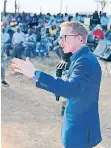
[60,21,88,42]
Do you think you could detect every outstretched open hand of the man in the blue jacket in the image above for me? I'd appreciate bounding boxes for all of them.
[12,58,36,78]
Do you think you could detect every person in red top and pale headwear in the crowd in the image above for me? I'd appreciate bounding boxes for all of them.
[93,25,104,40]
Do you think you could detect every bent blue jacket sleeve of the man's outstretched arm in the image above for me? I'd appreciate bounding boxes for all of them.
[36,58,92,98]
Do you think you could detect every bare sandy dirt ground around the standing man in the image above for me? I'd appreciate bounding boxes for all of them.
[1,54,111,148]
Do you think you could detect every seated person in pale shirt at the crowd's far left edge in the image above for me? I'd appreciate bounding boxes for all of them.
[1,28,10,57]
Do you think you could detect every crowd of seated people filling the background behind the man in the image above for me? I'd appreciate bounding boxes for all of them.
[1,11,111,59]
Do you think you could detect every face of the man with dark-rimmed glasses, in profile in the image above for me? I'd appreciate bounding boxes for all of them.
[59,27,82,53]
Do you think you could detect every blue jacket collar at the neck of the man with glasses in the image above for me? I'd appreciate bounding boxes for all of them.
[70,46,90,62]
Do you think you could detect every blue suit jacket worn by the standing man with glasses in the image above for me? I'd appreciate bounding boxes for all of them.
[36,46,101,148]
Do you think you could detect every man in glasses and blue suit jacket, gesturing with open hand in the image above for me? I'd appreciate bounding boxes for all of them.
[12,22,102,148]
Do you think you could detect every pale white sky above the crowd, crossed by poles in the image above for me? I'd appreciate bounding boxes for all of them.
[2,0,111,14]
